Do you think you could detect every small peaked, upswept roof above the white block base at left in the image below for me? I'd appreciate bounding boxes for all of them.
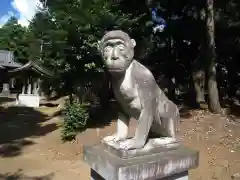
[8,61,53,77]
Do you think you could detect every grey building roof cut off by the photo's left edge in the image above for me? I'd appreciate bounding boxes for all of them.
[0,50,22,69]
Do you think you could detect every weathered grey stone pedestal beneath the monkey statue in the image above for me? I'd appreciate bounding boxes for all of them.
[84,140,199,180]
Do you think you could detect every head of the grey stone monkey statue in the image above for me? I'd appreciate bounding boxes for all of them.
[99,30,136,74]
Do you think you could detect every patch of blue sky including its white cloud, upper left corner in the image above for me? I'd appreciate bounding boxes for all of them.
[0,0,41,27]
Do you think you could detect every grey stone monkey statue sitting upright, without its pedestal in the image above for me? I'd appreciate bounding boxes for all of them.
[99,30,179,150]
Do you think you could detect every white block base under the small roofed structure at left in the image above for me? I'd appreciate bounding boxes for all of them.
[16,94,40,107]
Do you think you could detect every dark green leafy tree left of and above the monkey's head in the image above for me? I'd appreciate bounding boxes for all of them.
[29,0,142,101]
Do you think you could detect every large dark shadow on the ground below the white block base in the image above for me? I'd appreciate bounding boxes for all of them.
[0,106,58,157]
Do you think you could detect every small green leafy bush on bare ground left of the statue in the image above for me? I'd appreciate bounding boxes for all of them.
[61,102,89,141]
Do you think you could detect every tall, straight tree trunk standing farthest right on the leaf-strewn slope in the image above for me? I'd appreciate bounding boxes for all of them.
[206,0,221,113]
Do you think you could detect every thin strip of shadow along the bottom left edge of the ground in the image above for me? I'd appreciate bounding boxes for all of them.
[0,170,54,180]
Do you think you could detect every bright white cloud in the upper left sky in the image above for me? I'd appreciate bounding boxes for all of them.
[11,0,41,26]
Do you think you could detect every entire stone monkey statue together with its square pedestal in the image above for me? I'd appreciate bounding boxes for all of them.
[84,30,199,180]
